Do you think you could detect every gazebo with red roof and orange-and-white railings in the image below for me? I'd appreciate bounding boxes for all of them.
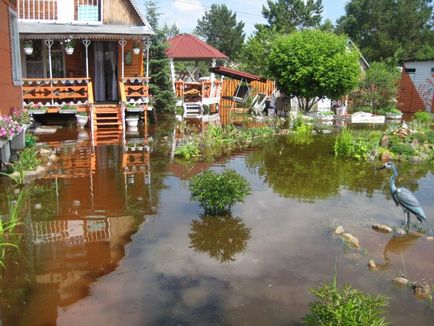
[166,34,228,118]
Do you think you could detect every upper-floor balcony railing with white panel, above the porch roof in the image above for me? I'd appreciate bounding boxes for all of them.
[17,0,103,23]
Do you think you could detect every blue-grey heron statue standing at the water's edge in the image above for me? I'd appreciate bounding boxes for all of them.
[377,162,426,228]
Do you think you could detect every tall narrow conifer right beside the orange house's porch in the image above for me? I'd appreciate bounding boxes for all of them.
[145,1,175,111]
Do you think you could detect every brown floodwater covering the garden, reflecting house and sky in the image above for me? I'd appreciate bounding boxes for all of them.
[0,123,434,325]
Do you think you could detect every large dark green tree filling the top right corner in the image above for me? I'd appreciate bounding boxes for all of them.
[337,0,434,64]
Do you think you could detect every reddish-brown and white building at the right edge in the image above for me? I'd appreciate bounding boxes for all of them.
[398,60,434,113]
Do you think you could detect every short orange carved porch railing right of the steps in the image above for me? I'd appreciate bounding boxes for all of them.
[119,77,149,104]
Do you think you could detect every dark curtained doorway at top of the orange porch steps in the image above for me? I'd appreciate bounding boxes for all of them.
[93,42,119,102]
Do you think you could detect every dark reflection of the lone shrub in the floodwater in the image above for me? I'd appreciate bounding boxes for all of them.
[188,215,250,263]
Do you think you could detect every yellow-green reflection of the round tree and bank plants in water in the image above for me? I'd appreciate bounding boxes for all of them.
[246,135,432,202]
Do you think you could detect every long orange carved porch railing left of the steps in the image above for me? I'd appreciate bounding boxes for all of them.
[23,78,93,107]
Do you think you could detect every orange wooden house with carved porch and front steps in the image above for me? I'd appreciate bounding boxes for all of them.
[17,0,153,131]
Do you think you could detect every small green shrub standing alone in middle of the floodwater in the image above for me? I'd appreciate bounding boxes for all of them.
[189,169,250,215]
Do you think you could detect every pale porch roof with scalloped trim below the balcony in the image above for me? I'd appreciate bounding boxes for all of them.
[18,22,154,39]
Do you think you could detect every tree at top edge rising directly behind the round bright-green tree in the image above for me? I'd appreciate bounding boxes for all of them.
[262,0,323,33]
